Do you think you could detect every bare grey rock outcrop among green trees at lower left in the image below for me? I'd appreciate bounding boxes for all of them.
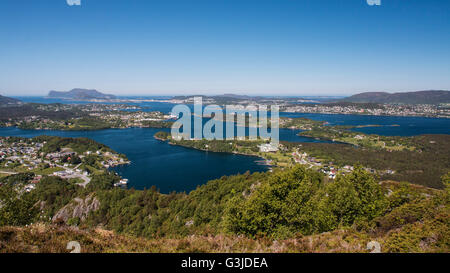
[52,196,100,223]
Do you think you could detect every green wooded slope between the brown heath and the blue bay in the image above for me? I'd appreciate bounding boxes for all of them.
[0,160,450,252]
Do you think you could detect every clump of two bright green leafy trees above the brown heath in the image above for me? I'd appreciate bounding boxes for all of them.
[225,166,388,238]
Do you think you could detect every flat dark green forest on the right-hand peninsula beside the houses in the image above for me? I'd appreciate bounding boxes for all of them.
[282,135,450,188]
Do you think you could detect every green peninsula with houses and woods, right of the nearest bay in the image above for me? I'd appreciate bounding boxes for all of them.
[154,115,450,188]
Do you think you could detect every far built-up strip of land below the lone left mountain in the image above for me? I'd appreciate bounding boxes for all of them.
[0,104,174,130]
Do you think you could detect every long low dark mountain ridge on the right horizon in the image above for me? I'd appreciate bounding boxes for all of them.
[339,90,450,104]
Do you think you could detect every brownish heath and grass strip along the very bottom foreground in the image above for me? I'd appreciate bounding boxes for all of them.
[0,210,449,253]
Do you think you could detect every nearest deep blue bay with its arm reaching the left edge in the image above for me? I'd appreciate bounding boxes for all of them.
[0,128,268,193]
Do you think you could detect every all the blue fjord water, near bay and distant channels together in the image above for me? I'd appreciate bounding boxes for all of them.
[4,97,450,193]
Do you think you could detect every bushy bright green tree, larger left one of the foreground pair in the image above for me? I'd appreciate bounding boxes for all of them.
[225,166,322,236]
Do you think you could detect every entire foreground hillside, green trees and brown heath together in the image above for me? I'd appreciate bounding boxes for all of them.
[0,134,450,253]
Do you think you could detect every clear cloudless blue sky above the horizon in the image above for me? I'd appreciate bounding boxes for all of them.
[0,0,450,96]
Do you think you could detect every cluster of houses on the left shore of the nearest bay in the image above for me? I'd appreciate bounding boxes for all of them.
[0,137,130,192]
